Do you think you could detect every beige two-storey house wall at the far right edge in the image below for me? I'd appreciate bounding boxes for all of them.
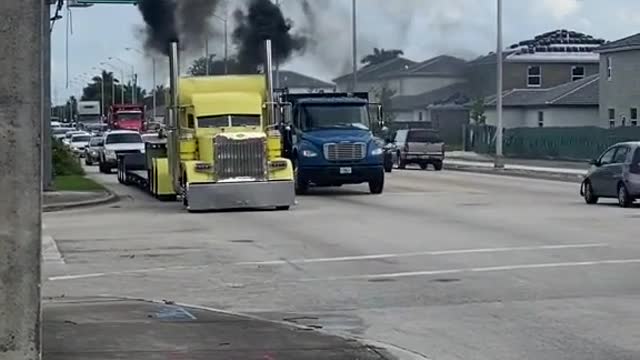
[600,50,640,127]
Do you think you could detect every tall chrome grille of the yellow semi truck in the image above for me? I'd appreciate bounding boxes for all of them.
[214,136,267,181]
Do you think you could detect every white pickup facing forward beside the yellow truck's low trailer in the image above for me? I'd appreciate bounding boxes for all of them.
[98,130,144,174]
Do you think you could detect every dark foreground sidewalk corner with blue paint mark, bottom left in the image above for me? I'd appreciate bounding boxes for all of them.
[43,298,392,360]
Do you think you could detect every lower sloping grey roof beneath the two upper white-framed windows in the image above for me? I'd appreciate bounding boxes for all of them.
[485,74,600,107]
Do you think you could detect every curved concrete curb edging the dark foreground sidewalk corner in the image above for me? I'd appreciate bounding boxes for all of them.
[92,294,431,360]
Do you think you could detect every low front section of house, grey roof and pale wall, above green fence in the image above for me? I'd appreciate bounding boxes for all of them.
[485,74,603,129]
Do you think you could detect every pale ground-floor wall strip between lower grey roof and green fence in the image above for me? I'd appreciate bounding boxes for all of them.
[485,106,602,129]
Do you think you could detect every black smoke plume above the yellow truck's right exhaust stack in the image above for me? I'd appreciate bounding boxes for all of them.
[232,0,307,73]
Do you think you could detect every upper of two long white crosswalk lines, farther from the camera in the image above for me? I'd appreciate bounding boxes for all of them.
[236,243,609,265]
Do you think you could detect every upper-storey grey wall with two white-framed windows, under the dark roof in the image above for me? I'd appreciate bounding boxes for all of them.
[468,62,599,97]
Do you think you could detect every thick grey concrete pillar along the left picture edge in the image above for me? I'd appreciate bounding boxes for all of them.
[0,0,44,360]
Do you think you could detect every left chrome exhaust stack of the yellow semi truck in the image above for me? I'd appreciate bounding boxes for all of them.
[167,41,181,194]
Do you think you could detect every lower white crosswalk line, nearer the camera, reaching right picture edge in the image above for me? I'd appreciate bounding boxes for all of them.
[299,259,640,282]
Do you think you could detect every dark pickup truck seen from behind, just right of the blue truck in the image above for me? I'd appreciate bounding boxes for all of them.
[392,129,445,171]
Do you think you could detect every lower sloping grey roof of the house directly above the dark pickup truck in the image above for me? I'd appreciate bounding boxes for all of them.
[391,83,469,111]
